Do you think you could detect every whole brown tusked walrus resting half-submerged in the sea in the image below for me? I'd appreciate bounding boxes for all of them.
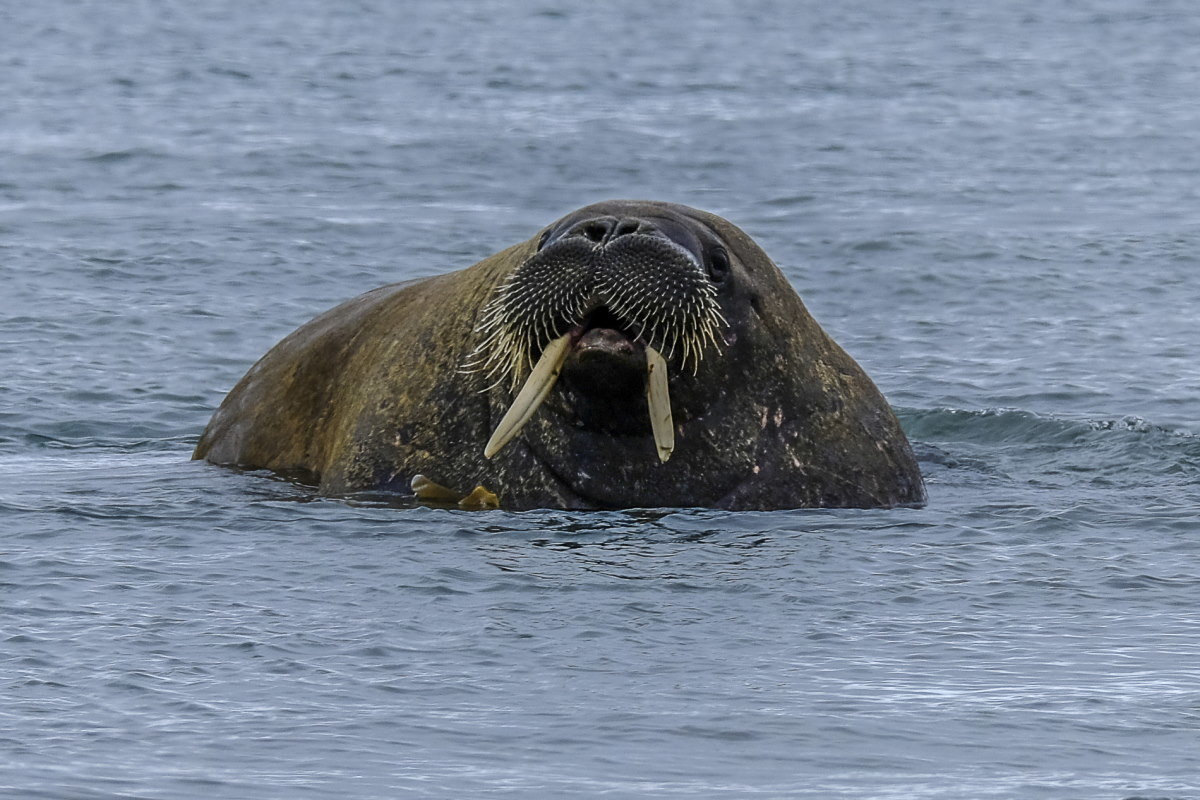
[194,200,925,510]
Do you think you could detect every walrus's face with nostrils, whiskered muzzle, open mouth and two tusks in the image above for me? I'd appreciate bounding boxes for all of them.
[469,200,730,462]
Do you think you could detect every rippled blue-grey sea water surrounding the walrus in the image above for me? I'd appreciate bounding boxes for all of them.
[0,0,1200,799]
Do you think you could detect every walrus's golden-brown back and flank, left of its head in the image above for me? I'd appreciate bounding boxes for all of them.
[192,237,523,494]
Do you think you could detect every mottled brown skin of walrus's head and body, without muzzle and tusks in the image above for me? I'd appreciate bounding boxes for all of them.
[194,201,925,509]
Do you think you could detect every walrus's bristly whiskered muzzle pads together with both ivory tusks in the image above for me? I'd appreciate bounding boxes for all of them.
[467,227,726,462]
